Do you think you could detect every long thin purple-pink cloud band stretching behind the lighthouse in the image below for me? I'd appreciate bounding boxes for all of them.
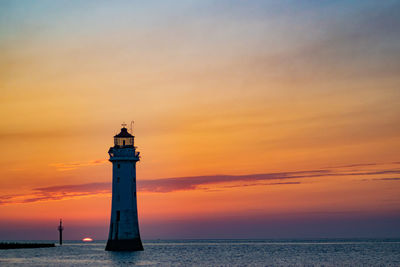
[0,163,400,205]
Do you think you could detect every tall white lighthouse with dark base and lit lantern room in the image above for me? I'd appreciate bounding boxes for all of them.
[106,124,143,251]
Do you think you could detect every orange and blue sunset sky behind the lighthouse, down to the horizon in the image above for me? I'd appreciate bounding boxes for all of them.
[0,0,400,240]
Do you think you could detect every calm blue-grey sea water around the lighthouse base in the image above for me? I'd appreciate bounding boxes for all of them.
[0,239,400,266]
